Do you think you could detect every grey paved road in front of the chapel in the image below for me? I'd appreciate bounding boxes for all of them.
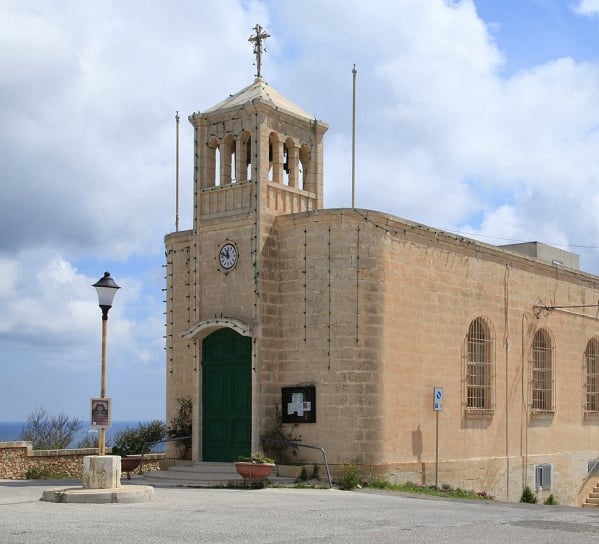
[0,480,599,544]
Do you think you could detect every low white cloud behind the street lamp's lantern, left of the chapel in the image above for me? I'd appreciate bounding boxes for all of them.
[0,252,164,378]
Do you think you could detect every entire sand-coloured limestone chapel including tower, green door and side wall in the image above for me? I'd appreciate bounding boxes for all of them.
[165,77,599,504]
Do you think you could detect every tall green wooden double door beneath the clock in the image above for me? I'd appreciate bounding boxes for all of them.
[202,329,252,461]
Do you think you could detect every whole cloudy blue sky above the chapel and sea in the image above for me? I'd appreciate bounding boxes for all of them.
[0,0,599,421]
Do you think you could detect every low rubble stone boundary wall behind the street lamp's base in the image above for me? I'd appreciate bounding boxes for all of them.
[0,441,164,480]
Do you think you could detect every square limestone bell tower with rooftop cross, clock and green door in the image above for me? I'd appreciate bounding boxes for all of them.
[165,25,328,460]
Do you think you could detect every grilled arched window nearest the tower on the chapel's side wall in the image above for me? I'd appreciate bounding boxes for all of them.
[466,317,495,410]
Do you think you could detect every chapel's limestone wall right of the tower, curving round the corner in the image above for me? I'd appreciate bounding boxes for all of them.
[260,210,599,504]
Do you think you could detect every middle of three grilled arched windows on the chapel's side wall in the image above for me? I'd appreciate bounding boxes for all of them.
[531,329,555,412]
